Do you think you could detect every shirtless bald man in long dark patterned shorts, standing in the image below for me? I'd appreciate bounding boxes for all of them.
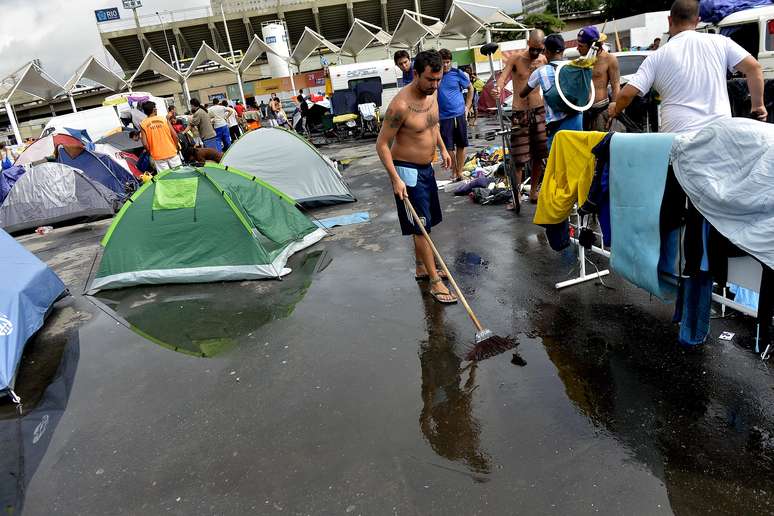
[500,29,548,210]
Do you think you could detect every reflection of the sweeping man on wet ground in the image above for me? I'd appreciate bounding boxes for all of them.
[419,290,491,473]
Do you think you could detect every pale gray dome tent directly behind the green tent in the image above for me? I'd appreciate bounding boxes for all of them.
[220,127,355,207]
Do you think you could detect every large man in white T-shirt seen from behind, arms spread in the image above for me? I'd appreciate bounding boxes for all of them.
[614,0,768,133]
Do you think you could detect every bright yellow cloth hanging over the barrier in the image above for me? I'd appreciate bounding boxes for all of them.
[533,131,606,224]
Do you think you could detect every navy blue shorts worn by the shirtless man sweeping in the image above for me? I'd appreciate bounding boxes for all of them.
[393,160,443,235]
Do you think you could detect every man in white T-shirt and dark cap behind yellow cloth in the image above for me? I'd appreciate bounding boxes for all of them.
[519,34,583,151]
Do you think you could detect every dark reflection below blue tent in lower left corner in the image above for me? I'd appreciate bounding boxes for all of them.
[0,328,80,514]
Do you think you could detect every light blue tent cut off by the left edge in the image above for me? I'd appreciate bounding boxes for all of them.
[0,230,66,397]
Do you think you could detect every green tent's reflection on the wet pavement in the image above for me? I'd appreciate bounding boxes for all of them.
[97,250,331,357]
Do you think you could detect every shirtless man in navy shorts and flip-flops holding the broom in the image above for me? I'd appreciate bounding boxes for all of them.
[376,50,457,304]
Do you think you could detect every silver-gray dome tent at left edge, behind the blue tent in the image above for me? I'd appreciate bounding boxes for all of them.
[0,163,119,233]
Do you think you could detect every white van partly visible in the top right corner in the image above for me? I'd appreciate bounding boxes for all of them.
[718,6,774,79]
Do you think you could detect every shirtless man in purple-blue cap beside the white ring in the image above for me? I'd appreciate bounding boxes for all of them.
[578,25,621,131]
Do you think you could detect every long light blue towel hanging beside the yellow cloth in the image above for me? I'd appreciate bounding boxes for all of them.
[610,133,675,301]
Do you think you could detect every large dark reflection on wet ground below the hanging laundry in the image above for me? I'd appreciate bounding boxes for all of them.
[536,305,774,514]
